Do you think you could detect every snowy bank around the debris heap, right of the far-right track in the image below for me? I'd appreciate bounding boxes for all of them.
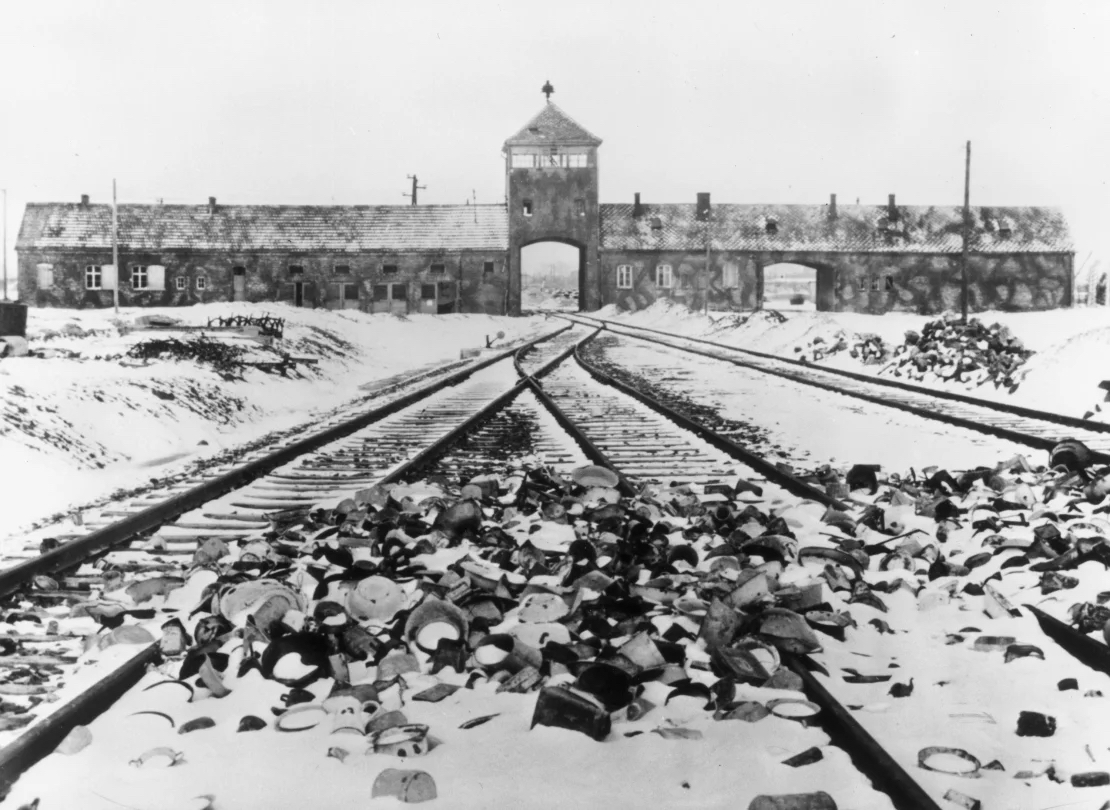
[594,302,1110,417]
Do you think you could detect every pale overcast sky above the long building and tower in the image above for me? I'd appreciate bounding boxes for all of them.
[0,0,1110,284]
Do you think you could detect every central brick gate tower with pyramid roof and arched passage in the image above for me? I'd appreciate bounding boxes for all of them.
[504,82,602,315]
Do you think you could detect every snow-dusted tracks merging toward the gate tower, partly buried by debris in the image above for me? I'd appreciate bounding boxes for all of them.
[0,319,1110,810]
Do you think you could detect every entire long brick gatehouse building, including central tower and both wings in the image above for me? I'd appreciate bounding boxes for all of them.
[16,88,1074,315]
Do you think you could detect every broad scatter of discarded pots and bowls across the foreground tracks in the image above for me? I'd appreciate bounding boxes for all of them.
[6,442,1110,808]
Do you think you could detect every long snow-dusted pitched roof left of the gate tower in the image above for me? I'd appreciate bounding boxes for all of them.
[16,203,508,252]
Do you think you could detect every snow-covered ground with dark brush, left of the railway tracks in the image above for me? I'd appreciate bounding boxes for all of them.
[0,303,557,537]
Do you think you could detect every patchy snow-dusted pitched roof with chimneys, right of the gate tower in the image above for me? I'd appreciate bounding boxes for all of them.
[601,203,1074,253]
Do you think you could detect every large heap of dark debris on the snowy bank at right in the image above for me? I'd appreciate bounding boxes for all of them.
[879,315,1033,393]
